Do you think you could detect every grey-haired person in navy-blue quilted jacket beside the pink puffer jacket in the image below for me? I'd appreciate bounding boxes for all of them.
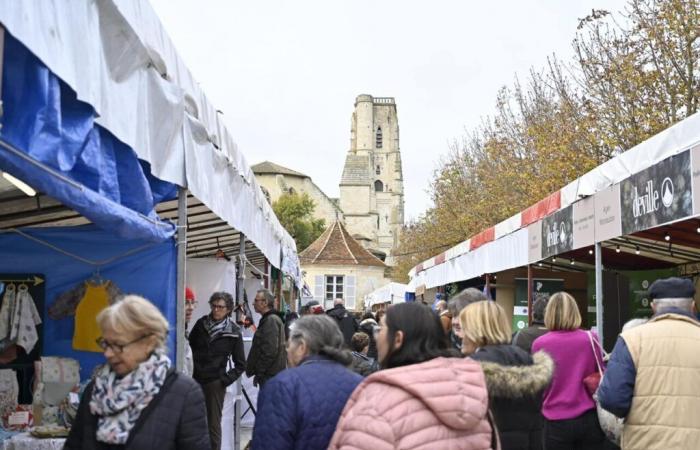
[251,315,362,450]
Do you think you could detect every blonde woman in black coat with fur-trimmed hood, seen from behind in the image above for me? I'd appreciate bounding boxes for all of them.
[459,301,554,450]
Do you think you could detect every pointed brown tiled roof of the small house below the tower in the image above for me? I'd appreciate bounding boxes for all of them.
[299,222,386,267]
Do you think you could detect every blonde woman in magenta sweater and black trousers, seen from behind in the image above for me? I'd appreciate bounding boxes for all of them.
[532,292,608,450]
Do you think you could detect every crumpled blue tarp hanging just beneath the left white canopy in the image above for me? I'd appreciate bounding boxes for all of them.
[0,33,177,241]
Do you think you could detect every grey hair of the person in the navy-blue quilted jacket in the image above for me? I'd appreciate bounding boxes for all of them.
[289,315,352,366]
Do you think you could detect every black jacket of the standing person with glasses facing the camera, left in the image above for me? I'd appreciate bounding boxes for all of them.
[190,316,245,386]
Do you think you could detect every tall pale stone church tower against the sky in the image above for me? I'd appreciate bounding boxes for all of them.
[340,95,404,266]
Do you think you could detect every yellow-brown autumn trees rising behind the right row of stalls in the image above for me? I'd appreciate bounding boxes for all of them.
[393,0,700,281]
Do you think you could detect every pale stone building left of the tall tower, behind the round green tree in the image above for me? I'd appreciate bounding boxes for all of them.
[251,161,344,226]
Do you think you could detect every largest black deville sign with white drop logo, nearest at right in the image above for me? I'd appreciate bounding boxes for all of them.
[620,150,693,234]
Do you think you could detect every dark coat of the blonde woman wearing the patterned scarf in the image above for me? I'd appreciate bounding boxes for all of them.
[63,369,211,450]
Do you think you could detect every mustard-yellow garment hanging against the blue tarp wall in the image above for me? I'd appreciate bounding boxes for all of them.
[73,281,112,353]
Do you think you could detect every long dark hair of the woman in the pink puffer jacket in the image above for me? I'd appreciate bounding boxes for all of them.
[380,302,459,369]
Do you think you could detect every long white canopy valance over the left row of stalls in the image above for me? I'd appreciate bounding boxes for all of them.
[0,0,300,276]
